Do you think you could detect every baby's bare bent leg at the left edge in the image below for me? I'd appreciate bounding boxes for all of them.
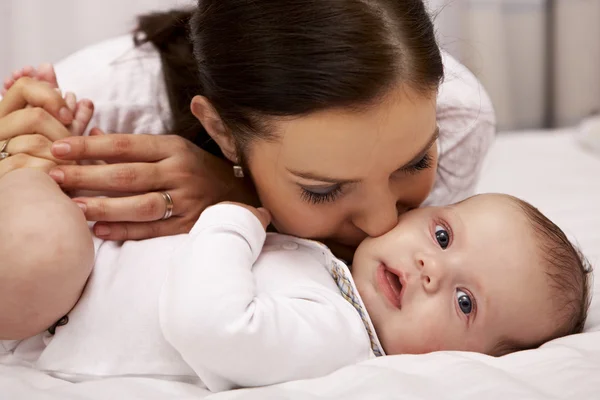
[0,169,94,339]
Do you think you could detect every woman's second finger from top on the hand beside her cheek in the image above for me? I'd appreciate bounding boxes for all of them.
[50,163,164,193]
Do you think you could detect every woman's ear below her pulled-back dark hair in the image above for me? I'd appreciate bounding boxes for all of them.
[190,96,238,163]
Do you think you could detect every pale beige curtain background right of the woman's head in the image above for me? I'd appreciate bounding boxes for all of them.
[429,0,600,129]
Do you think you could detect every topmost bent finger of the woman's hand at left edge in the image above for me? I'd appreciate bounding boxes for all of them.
[0,77,73,125]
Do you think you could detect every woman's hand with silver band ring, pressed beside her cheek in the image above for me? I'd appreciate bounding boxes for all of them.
[50,134,256,240]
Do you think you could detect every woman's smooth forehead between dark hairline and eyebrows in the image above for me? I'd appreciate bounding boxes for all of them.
[274,89,436,180]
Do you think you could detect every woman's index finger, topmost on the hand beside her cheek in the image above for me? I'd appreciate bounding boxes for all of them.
[52,133,186,162]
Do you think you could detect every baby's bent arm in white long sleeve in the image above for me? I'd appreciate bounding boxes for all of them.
[160,205,370,391]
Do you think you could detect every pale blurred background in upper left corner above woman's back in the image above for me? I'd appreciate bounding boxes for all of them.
[0,0,195,77]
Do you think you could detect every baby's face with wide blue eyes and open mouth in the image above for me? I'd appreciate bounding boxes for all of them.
[353,195,553,354]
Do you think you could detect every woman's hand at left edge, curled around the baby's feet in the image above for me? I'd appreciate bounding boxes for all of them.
[0,78,73,176]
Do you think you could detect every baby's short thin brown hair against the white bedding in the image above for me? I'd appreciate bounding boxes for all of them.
[492,196,592,356]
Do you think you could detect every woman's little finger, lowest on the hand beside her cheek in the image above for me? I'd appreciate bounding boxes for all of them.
[94,217,193,241]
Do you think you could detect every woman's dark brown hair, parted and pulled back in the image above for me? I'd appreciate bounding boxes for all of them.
[136,0,443,158]
